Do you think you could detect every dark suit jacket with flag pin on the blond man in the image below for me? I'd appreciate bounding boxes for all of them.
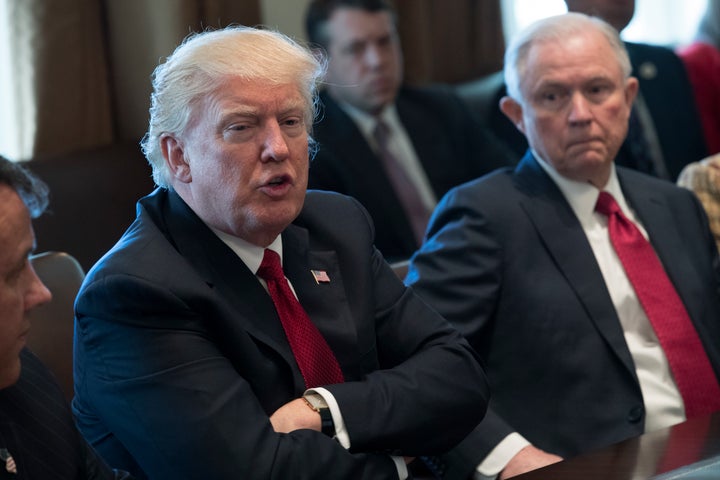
[73,190,488,480]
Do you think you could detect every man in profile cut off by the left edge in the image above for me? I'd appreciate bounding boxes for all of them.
[0,156,130,480]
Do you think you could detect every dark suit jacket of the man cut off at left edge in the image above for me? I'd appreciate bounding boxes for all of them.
[0,349,129,480]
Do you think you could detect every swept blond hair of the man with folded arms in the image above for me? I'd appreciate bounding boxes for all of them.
[141,26,326,188]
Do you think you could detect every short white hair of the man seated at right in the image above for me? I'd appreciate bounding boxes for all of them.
[503,13,632,103]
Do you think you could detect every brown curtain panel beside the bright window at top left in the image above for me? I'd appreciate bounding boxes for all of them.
[6,0,112,159]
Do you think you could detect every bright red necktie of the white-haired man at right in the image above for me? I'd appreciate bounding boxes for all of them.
[595,192,720,418]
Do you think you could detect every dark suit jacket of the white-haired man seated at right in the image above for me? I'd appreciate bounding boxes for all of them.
[407,154,720,473]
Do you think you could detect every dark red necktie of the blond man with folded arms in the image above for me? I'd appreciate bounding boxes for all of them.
[257,249,343,388]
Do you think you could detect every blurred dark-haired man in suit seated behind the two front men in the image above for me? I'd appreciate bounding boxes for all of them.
[306,0,510,260]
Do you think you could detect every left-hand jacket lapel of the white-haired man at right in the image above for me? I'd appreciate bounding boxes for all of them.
[515,153,635,377]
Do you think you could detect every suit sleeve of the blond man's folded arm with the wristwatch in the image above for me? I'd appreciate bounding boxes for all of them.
[296,195,489,456]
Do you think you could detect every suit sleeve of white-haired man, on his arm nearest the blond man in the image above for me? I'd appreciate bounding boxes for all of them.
[406,185,522,479]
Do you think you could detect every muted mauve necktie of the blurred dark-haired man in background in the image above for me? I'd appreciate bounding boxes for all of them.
[373,120,430,245]
